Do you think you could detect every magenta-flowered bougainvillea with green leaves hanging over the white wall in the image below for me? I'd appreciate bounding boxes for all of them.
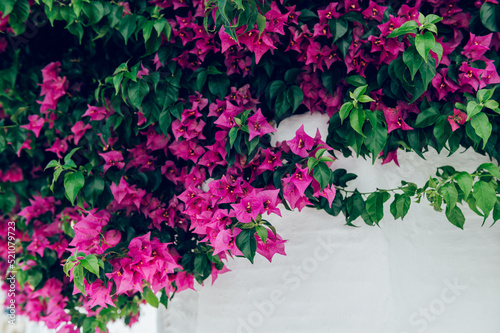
[0,0,500,332]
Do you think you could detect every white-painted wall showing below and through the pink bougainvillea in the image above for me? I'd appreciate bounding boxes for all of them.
[159,115,500,333]
